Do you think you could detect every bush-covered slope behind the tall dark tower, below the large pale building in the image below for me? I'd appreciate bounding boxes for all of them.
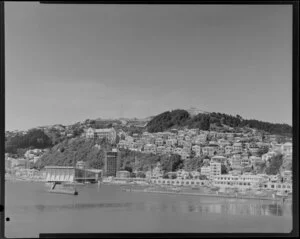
[35,138,183,174]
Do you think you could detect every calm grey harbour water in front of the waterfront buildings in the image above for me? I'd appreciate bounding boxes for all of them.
[5,182,292,238]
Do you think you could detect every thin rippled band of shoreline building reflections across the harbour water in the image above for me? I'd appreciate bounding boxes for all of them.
[20,200,291,216]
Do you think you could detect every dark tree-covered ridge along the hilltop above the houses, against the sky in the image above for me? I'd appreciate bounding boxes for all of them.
[147,109,292,136]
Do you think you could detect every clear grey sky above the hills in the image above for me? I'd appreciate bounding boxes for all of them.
[5,2,292,130]
